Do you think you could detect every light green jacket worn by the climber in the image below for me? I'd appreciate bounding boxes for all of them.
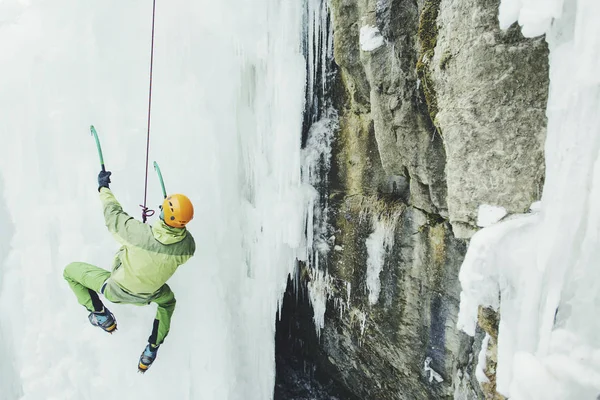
[100,188,196,296]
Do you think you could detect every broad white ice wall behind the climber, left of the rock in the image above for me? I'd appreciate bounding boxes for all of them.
[0,0,306,400]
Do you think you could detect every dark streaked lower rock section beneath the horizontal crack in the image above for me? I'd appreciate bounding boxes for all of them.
[321,197,471,400]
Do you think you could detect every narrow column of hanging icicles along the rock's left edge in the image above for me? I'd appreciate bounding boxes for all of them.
[302,0,338,334]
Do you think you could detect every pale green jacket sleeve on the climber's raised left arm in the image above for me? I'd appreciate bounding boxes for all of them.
[100,187,145,244]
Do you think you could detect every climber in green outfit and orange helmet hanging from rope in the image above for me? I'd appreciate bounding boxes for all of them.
[63,171,196,373]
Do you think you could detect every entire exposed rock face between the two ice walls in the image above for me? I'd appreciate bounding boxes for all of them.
[282,0,548,400]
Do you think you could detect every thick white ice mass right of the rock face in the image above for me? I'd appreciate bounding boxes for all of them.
[459,0,600,400]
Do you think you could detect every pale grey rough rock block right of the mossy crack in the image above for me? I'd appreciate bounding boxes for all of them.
[429,0,548,237]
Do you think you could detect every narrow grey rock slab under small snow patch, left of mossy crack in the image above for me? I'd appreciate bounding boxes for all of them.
[360,1,447,217]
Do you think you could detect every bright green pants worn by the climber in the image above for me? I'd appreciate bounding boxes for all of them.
[63,262,176,346]
